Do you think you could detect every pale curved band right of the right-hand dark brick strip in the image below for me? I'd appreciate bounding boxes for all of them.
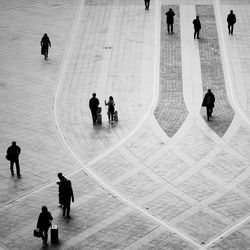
[213,0,250,125]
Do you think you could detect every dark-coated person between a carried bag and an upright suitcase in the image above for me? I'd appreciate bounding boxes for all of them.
[36,206,53,246]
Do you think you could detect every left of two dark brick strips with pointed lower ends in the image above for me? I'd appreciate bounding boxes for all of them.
[154,5,187,137]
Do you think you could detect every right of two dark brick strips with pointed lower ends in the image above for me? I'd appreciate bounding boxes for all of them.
[196,5,234,136]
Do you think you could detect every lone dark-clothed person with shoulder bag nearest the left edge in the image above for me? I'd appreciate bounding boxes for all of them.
[6,141,21,178]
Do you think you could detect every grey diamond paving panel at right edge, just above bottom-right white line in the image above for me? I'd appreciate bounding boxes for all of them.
[209,192,250,221]
